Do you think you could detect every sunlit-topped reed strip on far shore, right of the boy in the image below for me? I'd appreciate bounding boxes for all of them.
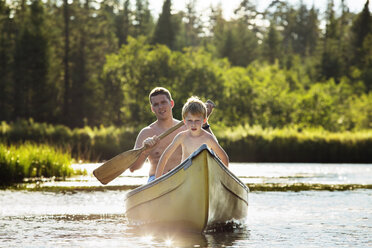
[214,125,372,163]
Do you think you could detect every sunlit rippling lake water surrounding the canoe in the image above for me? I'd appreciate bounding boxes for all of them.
[0,163,372,247]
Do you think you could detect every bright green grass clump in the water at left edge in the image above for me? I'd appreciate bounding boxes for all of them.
[0,143,74,184]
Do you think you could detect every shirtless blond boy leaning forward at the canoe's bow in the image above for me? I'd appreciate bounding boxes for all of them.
[155,97,229,178]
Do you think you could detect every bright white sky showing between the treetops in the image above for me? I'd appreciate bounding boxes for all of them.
[149,0,372,19]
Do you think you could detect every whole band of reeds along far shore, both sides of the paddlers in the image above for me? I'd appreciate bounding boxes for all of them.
[0,120,372,163]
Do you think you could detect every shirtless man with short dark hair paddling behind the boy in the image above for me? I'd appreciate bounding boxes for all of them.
[130,87,214,182]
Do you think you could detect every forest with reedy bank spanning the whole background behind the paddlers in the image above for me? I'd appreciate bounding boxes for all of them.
[0,0,372,162]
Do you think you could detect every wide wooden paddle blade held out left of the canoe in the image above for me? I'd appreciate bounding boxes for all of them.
[93,148,143,184]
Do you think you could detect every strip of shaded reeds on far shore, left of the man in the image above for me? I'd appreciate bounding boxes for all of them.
[0,119,139,162]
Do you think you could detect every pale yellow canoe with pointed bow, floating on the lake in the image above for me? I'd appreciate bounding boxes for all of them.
[125,145,249,232]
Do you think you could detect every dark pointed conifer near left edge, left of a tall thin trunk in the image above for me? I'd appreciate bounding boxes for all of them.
[14,0,53,121]
